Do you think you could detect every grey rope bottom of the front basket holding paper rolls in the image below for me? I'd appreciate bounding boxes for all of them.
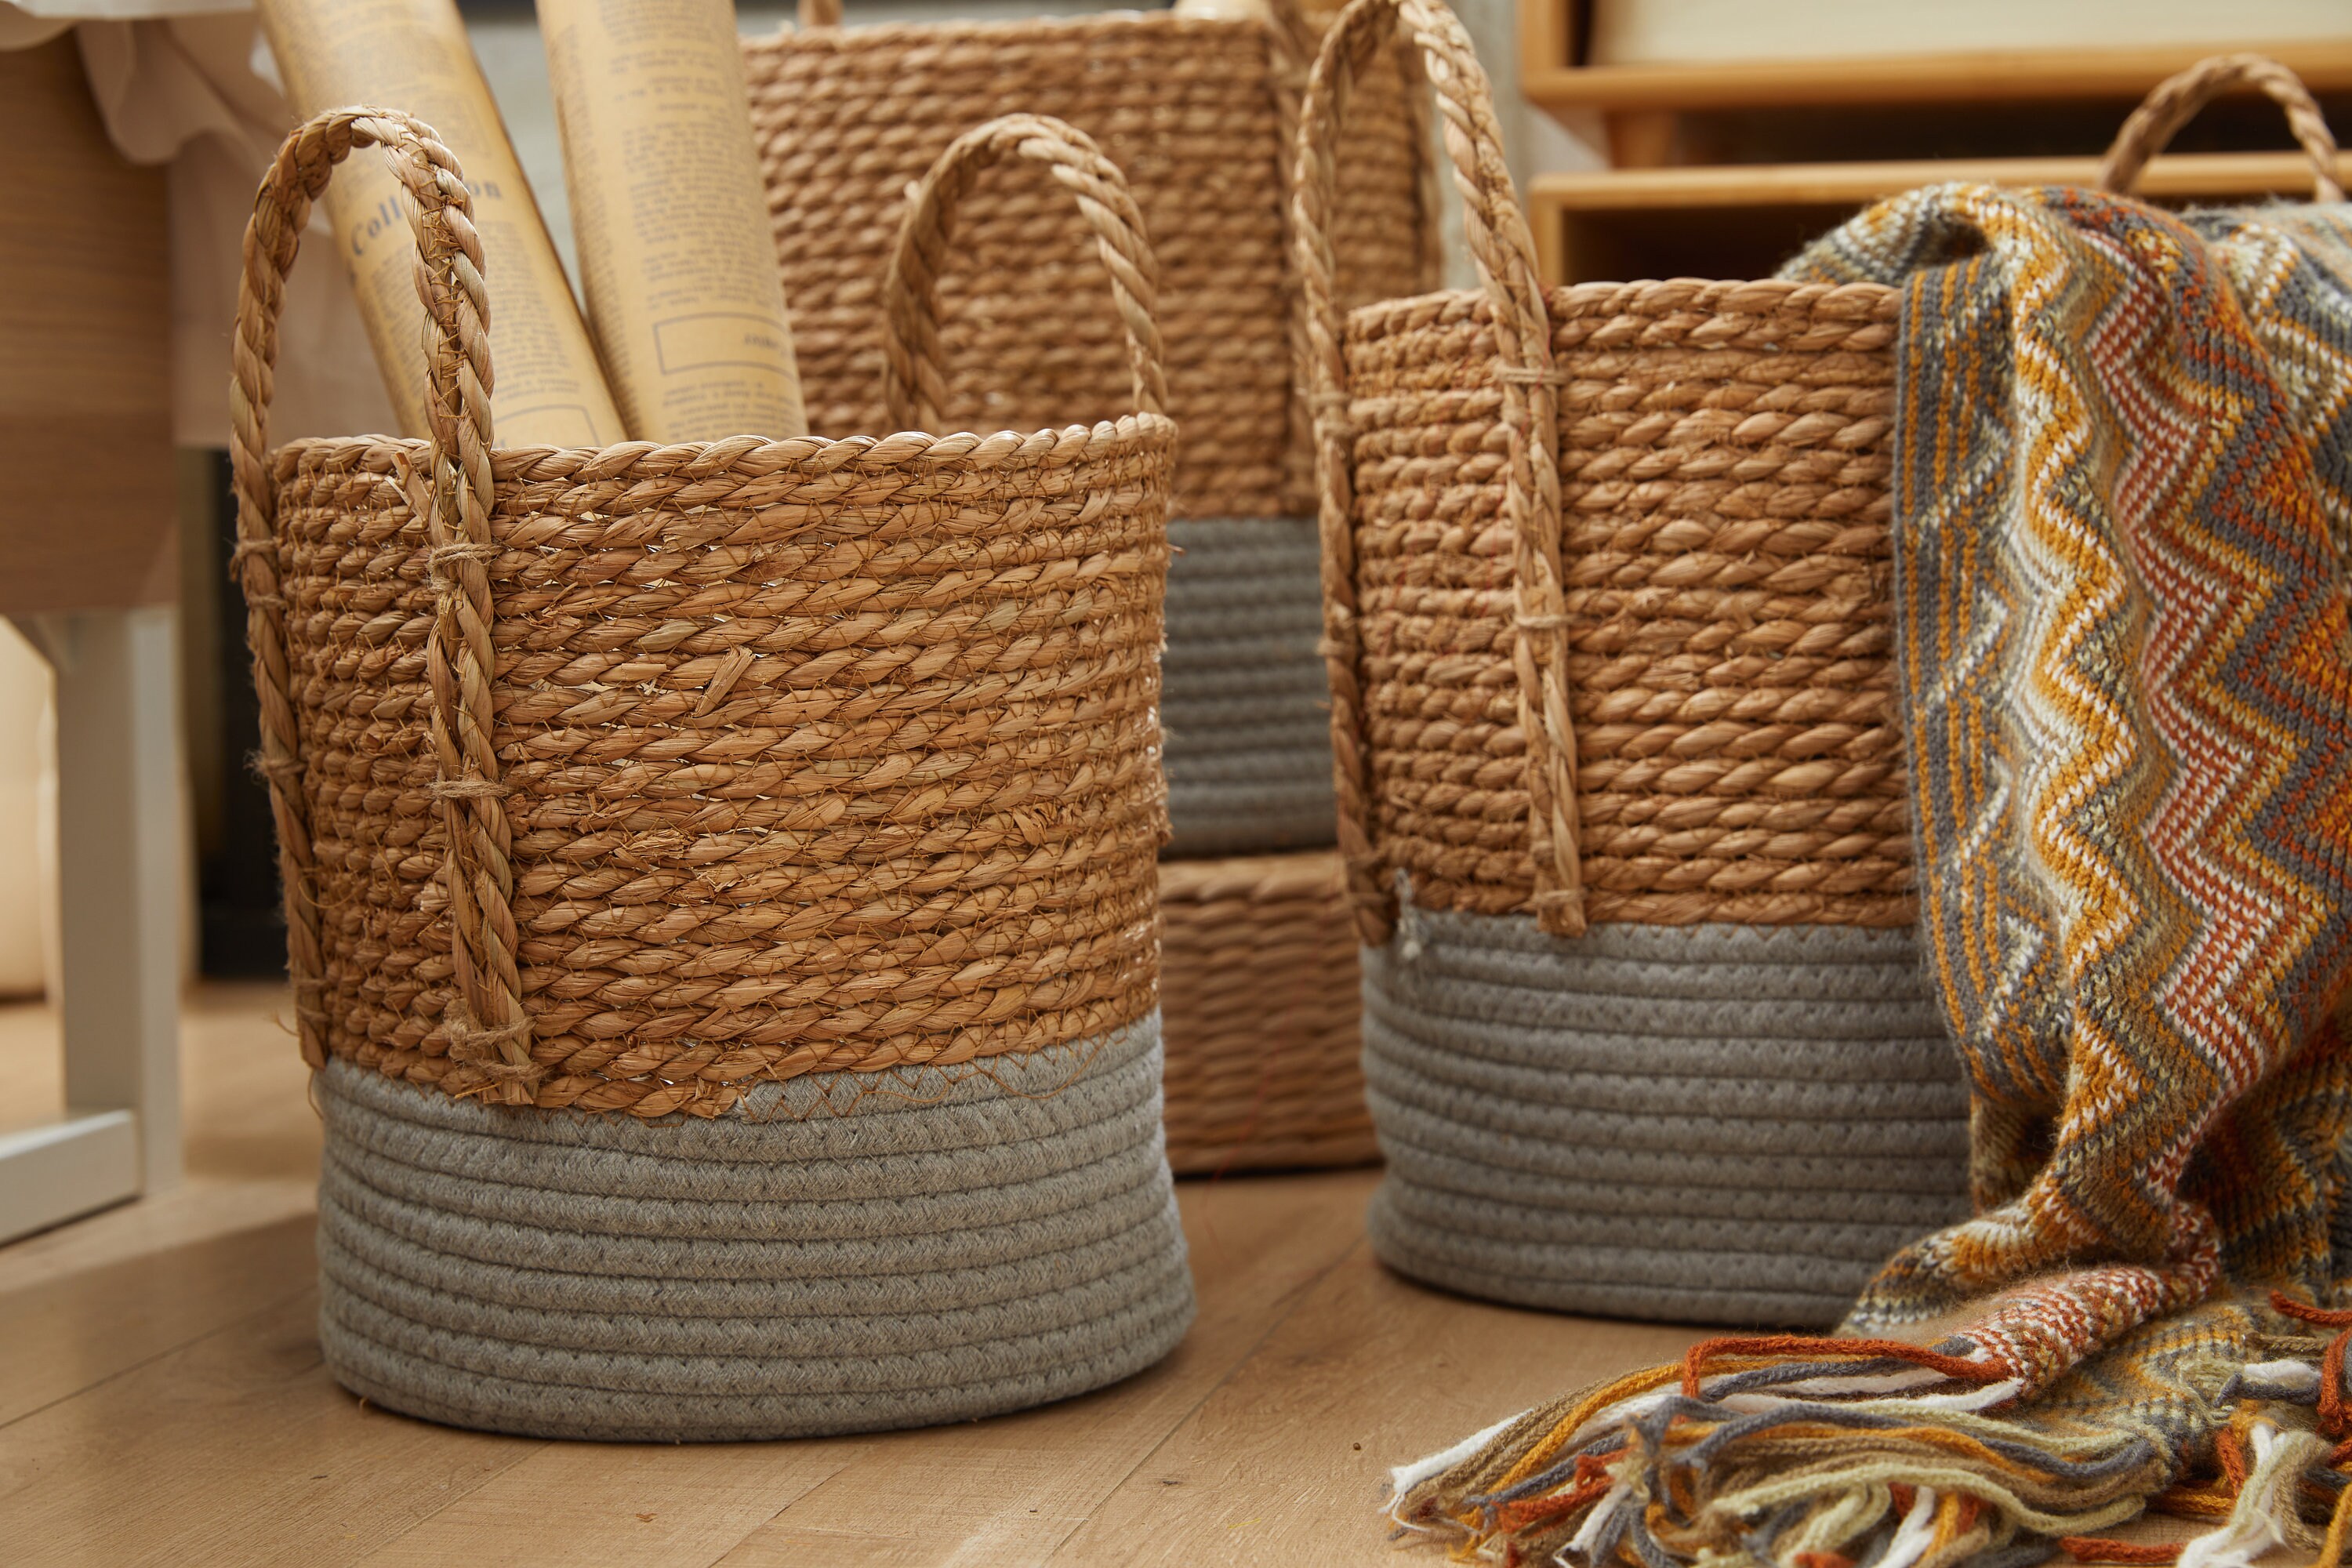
[318,1015,1192,1441]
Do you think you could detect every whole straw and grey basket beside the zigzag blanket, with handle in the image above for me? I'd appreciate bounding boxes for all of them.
[1296,0,1966,1323]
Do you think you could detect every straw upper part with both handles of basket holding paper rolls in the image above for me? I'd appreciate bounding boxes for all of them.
[235,111,1174,1116]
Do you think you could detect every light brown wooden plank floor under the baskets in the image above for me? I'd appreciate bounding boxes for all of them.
[0,987,1696,1568]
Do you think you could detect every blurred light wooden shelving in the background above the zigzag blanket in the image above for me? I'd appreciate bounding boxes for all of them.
[1517,0,2352,282]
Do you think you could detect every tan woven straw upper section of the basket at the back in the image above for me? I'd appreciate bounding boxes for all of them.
[746,12,1432,517]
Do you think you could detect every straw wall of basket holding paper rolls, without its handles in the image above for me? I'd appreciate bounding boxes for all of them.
[275,430,1169,1116]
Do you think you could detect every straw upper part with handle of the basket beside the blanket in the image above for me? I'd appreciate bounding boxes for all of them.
[1296,5,1912,942]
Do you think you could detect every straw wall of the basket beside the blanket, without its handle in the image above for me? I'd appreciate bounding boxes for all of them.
[1348,282,1912,926]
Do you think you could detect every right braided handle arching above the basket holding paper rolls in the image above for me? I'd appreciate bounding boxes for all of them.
[882,115,1169,430]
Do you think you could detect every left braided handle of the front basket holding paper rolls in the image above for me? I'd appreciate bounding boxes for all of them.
[228,108,541,1102]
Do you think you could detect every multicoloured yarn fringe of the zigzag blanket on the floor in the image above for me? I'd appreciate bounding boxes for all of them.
[1388,1298,2352,1568]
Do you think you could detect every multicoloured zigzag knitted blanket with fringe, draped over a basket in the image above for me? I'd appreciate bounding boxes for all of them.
[1395,186,2352,1568]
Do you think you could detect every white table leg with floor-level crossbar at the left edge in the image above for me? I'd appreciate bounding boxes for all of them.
[0,607,181,1241]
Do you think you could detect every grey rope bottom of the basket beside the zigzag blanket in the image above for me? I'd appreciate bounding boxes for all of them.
[1364,902,1969,1328]
